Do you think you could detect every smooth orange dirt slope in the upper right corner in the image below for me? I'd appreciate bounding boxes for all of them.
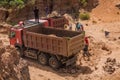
[91,0,120,22]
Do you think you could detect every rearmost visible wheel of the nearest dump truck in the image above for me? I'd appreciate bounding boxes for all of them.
[49,56,61,69]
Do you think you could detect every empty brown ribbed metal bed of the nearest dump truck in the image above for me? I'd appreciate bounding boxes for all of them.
[23,24,84,57]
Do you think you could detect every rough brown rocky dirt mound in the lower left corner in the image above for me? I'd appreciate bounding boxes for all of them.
[0,41,30,80]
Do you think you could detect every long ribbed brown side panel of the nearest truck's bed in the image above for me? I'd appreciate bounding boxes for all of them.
[23,31,68,57]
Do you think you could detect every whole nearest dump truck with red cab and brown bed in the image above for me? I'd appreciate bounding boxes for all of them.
[10,23,85,68]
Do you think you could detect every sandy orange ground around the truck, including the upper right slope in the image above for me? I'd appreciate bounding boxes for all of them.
[0,0,120,80]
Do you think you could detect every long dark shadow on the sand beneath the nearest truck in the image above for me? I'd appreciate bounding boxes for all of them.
[24,58,93,77]
